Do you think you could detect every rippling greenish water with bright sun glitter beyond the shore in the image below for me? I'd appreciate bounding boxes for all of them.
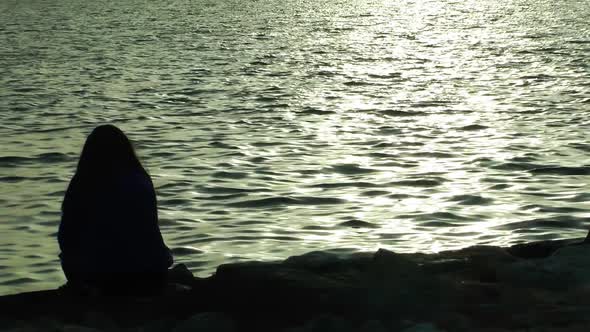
[0,0,590,294]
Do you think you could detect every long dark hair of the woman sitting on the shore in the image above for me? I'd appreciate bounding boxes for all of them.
[62,124,149,209]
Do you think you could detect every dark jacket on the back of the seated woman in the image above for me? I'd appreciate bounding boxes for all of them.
[58,172,173,281]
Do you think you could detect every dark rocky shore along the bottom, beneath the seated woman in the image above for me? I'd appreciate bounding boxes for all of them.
[0,239,590,332]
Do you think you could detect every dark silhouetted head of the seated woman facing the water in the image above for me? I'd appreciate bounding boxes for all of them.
[76,124,143,178]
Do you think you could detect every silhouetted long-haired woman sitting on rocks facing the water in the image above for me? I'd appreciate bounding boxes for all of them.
[58,125,172,294]
